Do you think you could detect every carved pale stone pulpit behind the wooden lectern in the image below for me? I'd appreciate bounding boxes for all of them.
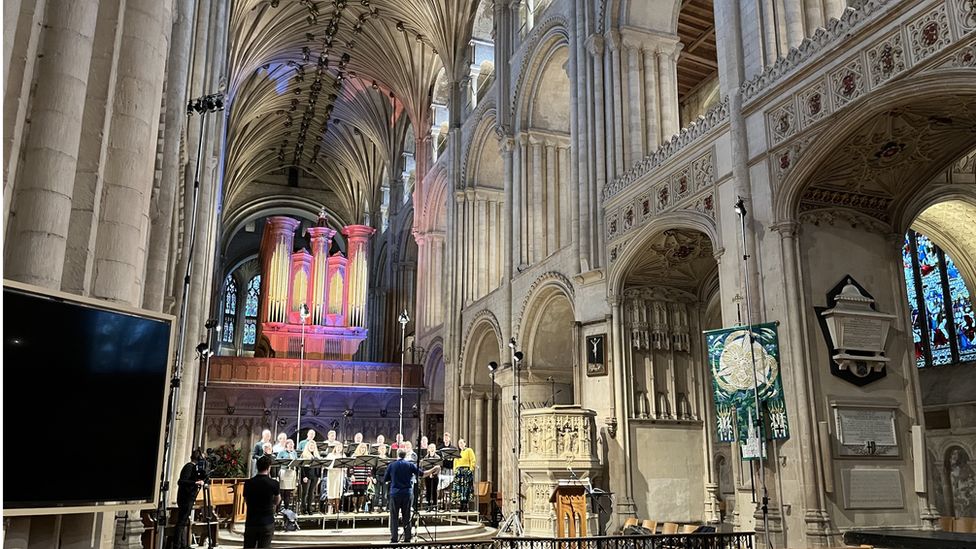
[519,405,601,537]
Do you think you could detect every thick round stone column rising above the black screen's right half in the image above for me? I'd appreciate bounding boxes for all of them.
[92,0,172,305]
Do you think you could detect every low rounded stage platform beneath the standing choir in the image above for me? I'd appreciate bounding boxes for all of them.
[217,511,496,547]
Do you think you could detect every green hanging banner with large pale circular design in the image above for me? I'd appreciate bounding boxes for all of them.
[704,322,790,458]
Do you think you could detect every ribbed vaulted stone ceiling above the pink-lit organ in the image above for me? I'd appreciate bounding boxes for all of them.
[225,0,479,222]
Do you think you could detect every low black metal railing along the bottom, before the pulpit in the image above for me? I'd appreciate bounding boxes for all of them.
[274,532,755,549]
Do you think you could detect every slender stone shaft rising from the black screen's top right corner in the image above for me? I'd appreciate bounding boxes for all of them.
[143,0,196,311]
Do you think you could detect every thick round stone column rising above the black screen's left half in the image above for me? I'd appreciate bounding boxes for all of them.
[4,0,99,290]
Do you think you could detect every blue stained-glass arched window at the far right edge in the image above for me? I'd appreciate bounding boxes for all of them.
[902,230,976,368]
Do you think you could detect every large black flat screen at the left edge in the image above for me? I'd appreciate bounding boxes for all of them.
[3,287,171,509]
